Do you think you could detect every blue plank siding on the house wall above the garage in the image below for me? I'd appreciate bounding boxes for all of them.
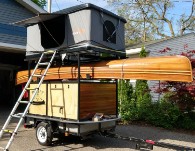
[0,0,35,46]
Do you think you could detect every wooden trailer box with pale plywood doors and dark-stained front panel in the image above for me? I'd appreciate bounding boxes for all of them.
[29,81,117,121]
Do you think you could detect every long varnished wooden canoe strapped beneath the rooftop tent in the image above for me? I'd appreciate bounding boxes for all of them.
[16,56,192,85]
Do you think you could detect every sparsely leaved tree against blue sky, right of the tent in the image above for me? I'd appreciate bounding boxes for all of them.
[108,0,195,44]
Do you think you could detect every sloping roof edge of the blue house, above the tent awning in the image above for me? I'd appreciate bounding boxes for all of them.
[16,0,47,14]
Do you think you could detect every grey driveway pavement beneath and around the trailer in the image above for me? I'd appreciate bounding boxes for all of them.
[0,109,195,151]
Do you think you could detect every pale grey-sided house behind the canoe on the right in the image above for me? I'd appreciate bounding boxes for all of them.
[126,33,195,101]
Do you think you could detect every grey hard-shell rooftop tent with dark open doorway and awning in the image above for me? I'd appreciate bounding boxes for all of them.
[17,4,126,56]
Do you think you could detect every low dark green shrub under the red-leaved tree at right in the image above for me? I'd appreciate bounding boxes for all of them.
[145,95,195,130]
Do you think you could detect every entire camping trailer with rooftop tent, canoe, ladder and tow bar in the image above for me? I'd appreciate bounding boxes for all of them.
[0,4,193,151]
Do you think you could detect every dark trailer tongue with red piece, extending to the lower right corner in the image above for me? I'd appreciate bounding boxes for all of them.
[100,132,195,151]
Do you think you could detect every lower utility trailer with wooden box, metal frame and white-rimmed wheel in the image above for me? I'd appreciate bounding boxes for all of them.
[25,80,119,145]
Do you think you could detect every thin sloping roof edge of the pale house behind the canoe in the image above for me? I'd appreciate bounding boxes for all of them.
[126,32,195,50]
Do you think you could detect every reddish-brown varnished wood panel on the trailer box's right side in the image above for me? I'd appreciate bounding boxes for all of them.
[79,83,117,119]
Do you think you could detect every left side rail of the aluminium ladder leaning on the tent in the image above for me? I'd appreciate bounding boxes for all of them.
[0,53,44,139]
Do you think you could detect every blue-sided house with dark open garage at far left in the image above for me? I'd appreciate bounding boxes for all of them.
[0,0,46,104]
